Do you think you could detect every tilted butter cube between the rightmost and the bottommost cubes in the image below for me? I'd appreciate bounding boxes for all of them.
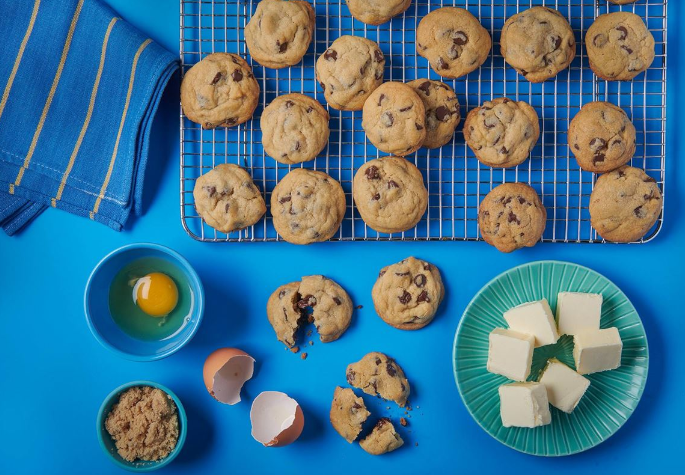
[538,358,590,414]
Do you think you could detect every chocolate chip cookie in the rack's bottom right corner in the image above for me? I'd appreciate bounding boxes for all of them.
[590,166,663,242]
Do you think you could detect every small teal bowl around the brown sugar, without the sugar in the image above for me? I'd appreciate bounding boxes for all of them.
[96,381,188,472]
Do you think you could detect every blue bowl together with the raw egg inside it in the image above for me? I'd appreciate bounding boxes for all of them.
[84,243,204,361]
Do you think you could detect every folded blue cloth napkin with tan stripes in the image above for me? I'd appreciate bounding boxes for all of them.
[0,0,178,235]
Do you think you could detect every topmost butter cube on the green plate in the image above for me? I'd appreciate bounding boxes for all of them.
[557,292,602,335]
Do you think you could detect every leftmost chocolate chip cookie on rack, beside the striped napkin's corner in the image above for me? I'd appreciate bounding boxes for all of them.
[181,53,259,129]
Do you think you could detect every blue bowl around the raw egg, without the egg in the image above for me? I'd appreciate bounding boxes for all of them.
[84,243,205,361]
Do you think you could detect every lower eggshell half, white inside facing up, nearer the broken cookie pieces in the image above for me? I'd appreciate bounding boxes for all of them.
[250,391,304,447]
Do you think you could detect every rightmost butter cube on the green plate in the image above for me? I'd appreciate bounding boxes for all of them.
[573,328,623,374]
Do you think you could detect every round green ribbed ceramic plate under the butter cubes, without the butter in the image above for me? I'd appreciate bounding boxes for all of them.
[453,261,649,456]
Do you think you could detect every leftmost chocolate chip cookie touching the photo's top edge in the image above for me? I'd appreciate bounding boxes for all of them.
[245,0,316,69]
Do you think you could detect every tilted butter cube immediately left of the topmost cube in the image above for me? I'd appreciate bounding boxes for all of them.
[504,299,559,348]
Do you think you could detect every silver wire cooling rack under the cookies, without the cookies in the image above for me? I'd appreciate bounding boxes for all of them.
[180,0,667,242]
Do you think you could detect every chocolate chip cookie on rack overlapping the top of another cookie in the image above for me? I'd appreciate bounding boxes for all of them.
[362,82,426,156]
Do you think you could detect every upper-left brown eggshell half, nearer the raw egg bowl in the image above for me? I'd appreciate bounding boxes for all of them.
[202,348,255,405]
